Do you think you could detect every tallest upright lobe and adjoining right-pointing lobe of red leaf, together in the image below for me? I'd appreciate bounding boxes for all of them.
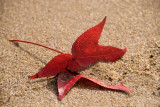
[68,17,127,71]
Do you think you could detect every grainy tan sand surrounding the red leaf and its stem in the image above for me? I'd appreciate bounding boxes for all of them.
[0,0,160,107]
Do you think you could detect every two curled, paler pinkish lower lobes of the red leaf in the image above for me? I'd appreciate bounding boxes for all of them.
[57,73,132,100]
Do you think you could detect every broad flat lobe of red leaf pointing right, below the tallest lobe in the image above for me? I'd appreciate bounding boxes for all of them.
[73,46,127,68]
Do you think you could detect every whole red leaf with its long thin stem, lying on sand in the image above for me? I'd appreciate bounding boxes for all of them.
[10,17,132,100]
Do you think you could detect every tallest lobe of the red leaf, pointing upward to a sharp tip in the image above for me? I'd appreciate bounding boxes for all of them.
[72,17,106,58]
